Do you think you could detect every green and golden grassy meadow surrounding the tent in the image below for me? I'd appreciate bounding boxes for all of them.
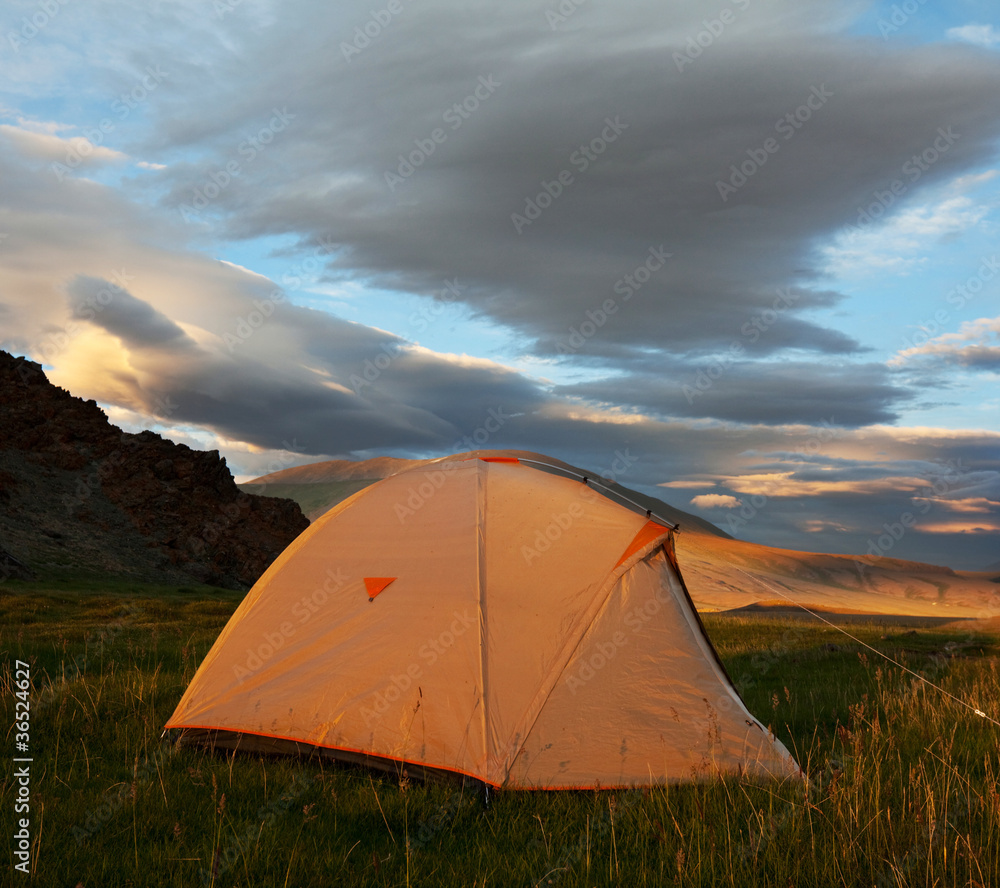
[0,580,1000,888]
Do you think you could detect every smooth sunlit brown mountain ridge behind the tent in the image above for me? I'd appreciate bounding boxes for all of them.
[241,451,1000,621]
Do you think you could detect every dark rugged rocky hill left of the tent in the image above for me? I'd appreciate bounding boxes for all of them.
[0,351,308,588]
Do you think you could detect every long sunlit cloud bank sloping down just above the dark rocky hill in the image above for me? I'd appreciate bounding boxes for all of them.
[0,136,548,455]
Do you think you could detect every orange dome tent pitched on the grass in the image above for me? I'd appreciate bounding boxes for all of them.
[166,451,801,789]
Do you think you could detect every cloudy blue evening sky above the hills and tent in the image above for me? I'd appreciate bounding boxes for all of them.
[0,0,1000,570]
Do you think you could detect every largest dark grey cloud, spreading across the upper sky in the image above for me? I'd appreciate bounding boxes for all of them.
[145,5,1000,372]
